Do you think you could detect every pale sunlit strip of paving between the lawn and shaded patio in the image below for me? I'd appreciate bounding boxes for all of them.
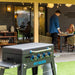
[55,52,75,62]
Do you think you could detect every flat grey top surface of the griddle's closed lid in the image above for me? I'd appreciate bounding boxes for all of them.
[3,43,53,50]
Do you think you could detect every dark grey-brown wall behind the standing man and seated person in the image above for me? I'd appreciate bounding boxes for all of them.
[47,5,75,32]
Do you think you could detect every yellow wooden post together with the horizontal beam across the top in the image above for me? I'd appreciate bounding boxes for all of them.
[0,0,75,42]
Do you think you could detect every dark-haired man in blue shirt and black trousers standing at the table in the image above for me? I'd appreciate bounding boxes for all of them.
[49,10,61,52]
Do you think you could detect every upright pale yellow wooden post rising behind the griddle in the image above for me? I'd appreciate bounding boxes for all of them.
[34,3,39,43]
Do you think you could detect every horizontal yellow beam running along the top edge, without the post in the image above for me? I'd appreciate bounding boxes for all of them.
[0,0,75,4]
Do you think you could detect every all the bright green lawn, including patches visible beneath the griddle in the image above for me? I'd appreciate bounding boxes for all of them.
[4,61,75,75]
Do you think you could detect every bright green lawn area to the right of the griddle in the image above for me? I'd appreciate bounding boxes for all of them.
[57,61,75,75]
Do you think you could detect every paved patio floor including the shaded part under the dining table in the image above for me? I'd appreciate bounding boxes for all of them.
[55,47,75,62]
